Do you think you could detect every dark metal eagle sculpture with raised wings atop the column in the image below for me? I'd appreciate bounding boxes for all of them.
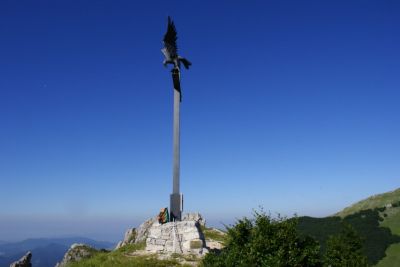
[161,16,192,70]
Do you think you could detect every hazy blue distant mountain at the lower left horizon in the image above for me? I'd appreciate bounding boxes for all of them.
[0,237,115,267]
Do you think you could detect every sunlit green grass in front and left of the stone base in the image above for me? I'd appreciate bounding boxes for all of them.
[68,243,188,267]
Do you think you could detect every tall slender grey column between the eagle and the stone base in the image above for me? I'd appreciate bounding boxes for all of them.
[170,68,183,221]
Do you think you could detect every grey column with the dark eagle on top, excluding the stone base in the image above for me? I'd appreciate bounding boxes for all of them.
[161,17,192,221]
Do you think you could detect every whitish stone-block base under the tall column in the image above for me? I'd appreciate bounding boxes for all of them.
[146,221,207,254]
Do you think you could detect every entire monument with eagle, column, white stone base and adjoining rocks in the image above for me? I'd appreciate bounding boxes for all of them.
[116,17,208,257]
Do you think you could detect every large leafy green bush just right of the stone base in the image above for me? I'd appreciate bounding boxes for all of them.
[202,212,321,267]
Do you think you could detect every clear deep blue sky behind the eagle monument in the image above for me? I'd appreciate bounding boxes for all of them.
[0,0,400,243]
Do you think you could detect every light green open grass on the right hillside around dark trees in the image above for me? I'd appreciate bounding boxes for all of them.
[336,188,400,267]
